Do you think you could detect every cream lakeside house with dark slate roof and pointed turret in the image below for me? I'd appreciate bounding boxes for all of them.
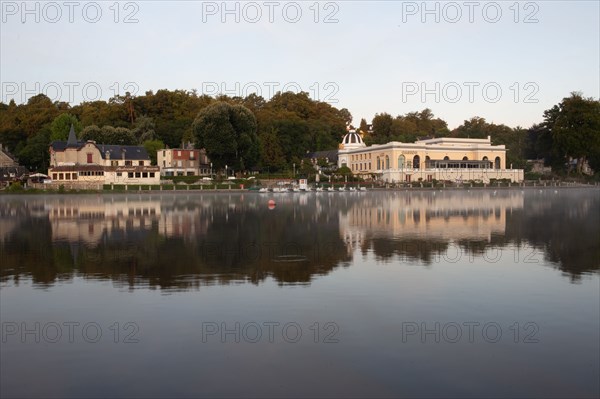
[48,127,160,185]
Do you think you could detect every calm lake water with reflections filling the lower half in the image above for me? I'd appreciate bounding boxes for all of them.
[0,188,600,397]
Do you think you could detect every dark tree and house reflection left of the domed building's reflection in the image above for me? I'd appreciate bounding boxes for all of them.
[0,195,351,289]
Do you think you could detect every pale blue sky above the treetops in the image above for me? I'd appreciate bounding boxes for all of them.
[0,1,600,128]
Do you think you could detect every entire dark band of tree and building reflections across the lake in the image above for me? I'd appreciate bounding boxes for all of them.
[0,190,600,290]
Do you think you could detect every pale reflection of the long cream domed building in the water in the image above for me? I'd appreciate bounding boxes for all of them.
[340,191,524,250]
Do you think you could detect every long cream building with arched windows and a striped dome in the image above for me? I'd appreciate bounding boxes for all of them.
[338,131,523,183]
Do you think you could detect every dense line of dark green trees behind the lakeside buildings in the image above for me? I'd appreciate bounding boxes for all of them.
[0,90,600,179]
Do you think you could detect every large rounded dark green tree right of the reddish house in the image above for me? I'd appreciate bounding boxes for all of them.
[193,101,259,170]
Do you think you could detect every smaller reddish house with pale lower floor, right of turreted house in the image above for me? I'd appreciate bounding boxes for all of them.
[157,148,211,176]
